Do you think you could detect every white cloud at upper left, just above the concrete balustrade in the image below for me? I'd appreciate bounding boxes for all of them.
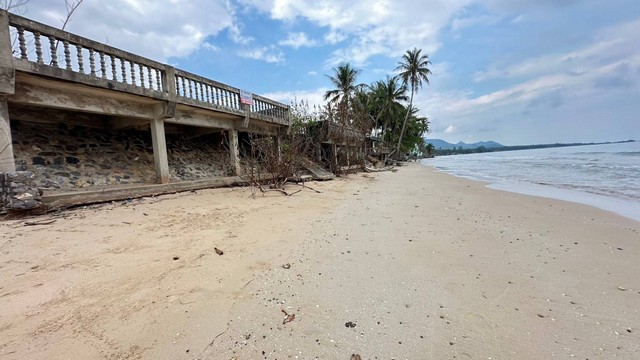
[26,0,240,62]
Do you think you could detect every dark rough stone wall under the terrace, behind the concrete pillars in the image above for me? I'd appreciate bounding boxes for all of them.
[11,119,232,191]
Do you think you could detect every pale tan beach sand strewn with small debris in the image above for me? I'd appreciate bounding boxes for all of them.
[0,163,640,359]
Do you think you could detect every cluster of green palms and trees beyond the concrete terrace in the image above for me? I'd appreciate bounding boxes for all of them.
[292,49,432,157]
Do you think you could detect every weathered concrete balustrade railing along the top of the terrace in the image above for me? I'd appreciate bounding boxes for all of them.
[2,13,289,125]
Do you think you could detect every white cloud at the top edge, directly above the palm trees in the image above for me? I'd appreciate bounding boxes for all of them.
[242,0,472,67]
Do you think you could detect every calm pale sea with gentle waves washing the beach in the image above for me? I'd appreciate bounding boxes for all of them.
[421,142,640,221]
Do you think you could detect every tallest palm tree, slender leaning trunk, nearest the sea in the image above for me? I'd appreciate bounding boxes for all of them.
[395,48,431,157]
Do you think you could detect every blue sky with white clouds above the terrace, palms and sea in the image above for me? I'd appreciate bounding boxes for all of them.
[8,0,640,145]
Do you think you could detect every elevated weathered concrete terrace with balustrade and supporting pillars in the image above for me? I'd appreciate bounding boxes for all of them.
[0,11,290,208]
